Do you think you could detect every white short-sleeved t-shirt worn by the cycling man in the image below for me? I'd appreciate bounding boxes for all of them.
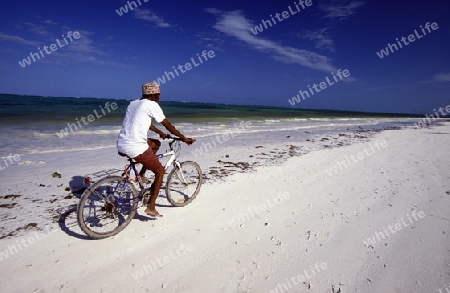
[117,99,166,158]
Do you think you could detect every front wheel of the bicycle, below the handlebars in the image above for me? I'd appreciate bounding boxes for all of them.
[166,161,202,207]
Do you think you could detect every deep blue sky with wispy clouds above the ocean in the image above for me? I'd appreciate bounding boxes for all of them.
[0,0,450,115]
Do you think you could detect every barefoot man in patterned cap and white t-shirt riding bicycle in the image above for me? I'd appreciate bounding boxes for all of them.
[117,82,195,217]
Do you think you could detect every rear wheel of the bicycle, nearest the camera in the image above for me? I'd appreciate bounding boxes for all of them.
[77,176,139,239]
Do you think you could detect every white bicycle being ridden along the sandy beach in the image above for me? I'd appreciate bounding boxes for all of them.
[77,136,202,239]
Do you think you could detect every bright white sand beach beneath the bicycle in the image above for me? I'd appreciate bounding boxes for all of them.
[0,122,450,293]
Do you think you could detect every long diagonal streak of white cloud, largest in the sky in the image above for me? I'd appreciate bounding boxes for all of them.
[206,8,336,72]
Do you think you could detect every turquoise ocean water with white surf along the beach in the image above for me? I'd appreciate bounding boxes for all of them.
[0,94,421,157]
